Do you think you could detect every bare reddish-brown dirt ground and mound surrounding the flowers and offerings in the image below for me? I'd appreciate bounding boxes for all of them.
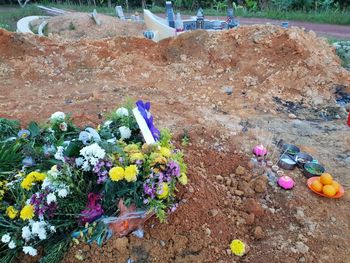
[0,26,350,263]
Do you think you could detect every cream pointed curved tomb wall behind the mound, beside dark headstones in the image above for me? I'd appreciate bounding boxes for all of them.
[143,10,176,42]
